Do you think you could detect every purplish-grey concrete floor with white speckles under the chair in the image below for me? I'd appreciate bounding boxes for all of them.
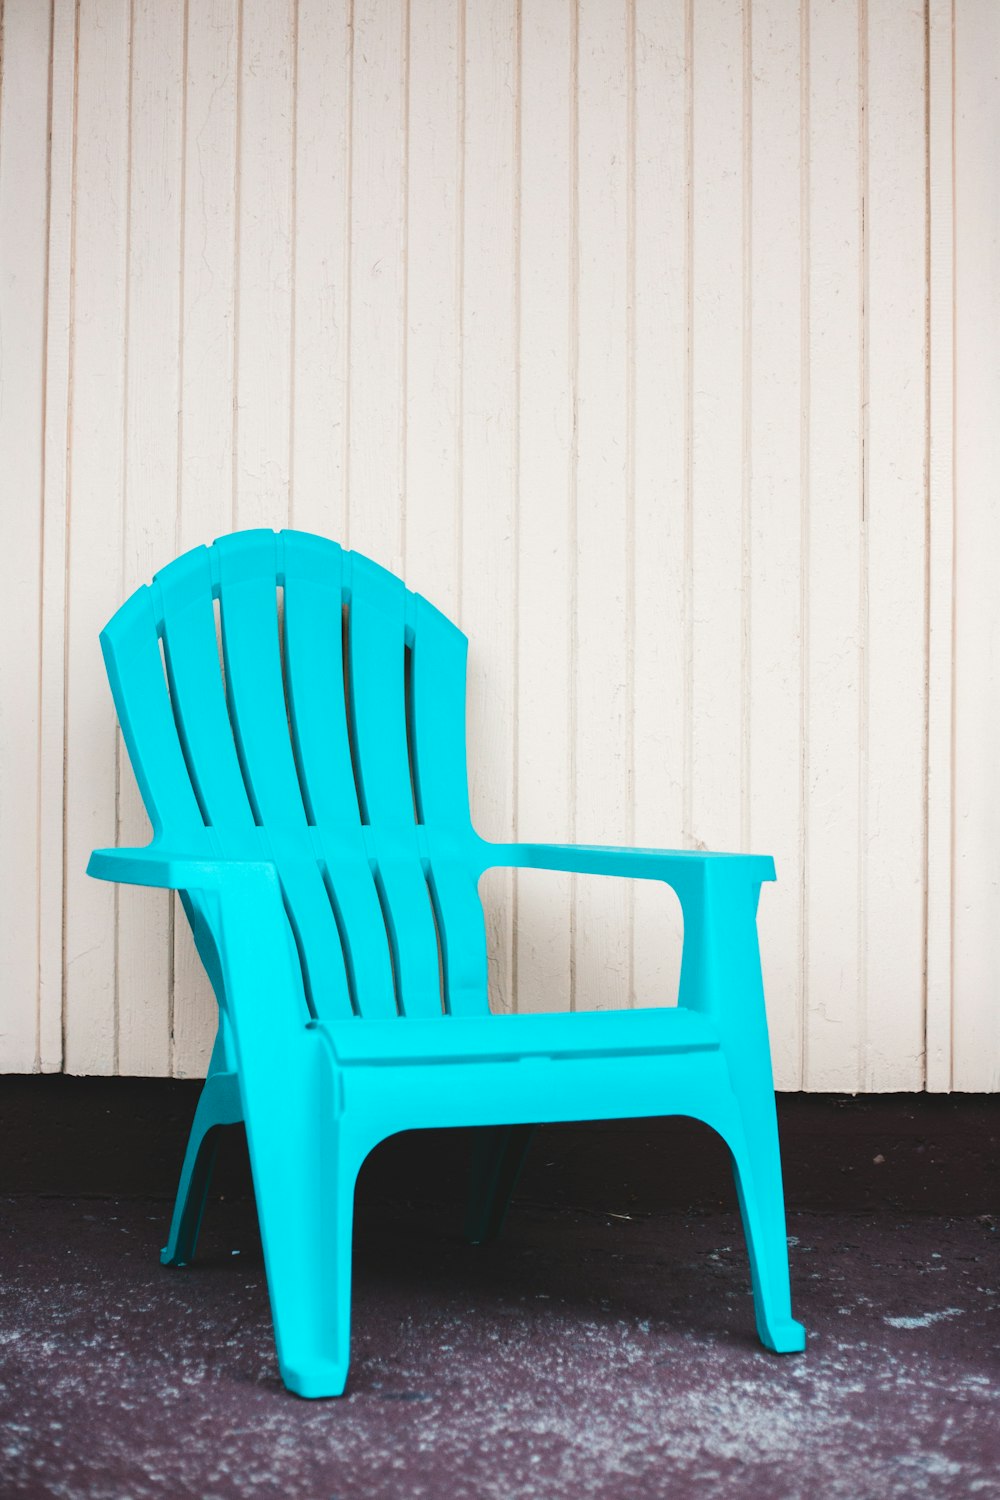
[0,1200,1000,1500]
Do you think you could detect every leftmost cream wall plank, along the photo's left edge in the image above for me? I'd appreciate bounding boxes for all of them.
[0,0,51,1073]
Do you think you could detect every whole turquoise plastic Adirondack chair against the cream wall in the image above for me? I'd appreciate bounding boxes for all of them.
[88,531,805,1397]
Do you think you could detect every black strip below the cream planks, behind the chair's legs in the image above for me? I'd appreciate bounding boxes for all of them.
[0,1074,1000,1215]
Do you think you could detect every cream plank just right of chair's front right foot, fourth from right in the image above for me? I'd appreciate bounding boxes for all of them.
[802,0,862,1091]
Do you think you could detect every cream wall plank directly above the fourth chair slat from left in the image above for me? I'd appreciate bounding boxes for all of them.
[289,0,351,542]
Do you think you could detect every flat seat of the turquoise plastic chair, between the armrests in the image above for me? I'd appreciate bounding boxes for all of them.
[321,1005,720,1067]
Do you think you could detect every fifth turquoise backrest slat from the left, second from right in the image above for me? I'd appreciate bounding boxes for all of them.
[348,557,441,1016]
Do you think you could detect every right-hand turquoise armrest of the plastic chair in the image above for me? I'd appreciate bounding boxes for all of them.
[481,840,775,894]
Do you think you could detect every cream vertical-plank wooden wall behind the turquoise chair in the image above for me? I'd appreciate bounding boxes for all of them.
[0,0,1000,1091]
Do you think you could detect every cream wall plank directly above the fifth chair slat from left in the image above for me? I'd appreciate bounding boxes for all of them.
[346,0,408,573]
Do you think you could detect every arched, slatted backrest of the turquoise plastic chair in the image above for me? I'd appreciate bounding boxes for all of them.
[100,531,489,1020]
